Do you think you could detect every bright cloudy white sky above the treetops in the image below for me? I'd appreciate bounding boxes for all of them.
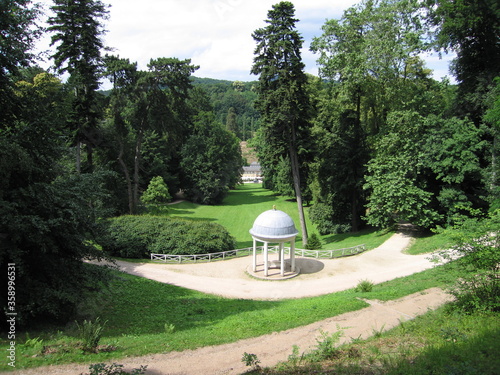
[38,0,453,81]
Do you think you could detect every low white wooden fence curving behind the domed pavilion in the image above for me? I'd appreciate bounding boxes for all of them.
[151,244,366,263]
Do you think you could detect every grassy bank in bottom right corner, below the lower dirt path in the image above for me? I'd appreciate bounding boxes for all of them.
[249,306,500,375]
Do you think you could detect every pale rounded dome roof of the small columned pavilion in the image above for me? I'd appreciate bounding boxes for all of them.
[250,209,299,242]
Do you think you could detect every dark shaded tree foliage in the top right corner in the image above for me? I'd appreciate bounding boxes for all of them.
[427,0,500,125]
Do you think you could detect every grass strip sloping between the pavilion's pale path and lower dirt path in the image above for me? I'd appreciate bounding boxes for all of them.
[0,265,460,371]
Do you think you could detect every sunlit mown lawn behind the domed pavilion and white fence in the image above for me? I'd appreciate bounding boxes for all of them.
[164,184,392,250]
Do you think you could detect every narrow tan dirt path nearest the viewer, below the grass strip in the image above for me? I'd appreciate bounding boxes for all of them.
[14,288,451,375]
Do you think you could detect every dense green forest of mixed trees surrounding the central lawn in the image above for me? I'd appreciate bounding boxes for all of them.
[0,0,500,323]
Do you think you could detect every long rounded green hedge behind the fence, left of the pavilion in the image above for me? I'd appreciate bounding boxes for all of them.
[98,215,236,258]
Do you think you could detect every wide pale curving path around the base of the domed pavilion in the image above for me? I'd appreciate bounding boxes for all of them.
[108,233,434,299]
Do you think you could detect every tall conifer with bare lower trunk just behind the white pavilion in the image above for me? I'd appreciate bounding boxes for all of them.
[251,1,310,244]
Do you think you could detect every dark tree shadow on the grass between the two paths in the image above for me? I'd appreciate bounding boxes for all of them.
[100,265,281,337]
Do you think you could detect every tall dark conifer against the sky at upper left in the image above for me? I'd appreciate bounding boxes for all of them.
[48,0,108,172]
